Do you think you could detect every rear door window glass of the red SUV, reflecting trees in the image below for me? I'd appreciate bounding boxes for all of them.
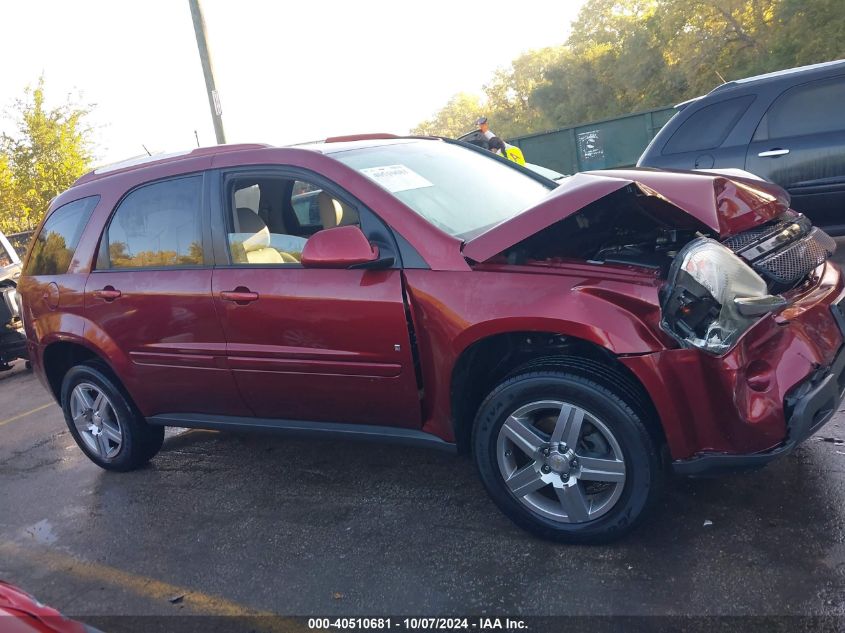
[97,176,203,269]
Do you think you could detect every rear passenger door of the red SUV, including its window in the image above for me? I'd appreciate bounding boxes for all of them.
[85,175,245,416]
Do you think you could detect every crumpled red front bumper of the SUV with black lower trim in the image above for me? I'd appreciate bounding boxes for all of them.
[620,263,845,476]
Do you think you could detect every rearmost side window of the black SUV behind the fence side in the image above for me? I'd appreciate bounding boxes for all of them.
[662,95,754,154]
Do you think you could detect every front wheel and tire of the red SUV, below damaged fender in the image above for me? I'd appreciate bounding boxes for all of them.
[473,363,663,543]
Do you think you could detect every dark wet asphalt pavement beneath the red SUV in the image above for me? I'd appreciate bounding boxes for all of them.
[0,239,845,630]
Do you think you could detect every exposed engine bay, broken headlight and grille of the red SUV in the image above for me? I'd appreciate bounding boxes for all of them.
[502,187,836,354]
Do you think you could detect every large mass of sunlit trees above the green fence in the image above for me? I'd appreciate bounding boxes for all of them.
[418,0,845,137]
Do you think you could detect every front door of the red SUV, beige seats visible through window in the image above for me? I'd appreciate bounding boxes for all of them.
[212,169,421,428]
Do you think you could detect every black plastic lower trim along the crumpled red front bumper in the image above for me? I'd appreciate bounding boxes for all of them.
[672,340,845,477]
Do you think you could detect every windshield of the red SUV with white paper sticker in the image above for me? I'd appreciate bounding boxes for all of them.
[332,141,550,239]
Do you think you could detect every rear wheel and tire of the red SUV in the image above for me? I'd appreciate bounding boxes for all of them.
[61,362,164,471]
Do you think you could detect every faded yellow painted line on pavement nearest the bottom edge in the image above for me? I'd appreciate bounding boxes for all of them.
[0,542,307,633]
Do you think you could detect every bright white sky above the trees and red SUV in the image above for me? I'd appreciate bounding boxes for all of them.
[0,0,584,163]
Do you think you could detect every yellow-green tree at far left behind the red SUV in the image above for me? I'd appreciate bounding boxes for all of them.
[0,77,92,233]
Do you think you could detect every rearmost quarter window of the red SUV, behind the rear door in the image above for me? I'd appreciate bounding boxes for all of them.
[24,196,100,275]
